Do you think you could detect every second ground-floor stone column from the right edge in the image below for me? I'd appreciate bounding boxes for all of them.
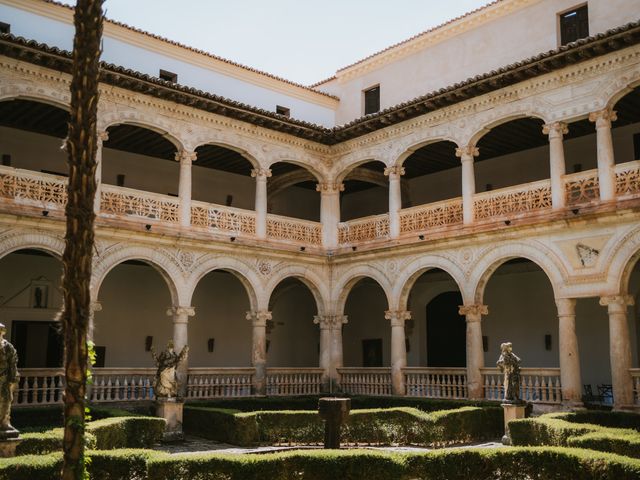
[556,298,582,407]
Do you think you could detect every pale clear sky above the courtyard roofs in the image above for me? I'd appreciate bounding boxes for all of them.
[58,0,489,85]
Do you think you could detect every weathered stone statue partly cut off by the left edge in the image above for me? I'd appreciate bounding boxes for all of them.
[0,323,20,441]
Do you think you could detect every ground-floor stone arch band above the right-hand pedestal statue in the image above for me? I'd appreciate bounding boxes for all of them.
[463,243,567,304]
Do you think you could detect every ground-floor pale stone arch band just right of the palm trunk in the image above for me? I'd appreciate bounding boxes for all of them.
[91,246,182,306]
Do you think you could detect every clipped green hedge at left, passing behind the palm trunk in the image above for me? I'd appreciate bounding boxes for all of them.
[16,417,165,455]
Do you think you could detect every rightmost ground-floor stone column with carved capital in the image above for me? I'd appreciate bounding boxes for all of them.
[600,295,633,410]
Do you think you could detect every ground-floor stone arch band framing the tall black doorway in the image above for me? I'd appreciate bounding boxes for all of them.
[393,255,472,310]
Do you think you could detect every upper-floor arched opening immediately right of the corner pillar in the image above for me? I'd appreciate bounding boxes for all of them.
[340,160,389,222]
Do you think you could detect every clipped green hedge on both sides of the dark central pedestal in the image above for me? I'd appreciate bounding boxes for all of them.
[183,405,504,446]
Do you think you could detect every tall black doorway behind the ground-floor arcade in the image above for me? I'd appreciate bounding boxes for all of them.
[427,292,467,367]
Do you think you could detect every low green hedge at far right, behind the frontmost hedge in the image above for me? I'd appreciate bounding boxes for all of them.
[509,412,640,458]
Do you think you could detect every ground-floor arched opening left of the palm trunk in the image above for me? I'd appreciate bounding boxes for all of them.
[0,249,63,369]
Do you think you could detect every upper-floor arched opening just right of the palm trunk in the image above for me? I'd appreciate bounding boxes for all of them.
[102,123,180,197]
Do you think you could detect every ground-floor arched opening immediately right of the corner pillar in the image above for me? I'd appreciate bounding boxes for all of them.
[342,277,391,367]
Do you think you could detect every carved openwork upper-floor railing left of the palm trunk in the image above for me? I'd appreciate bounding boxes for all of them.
[0,166,68,210]
